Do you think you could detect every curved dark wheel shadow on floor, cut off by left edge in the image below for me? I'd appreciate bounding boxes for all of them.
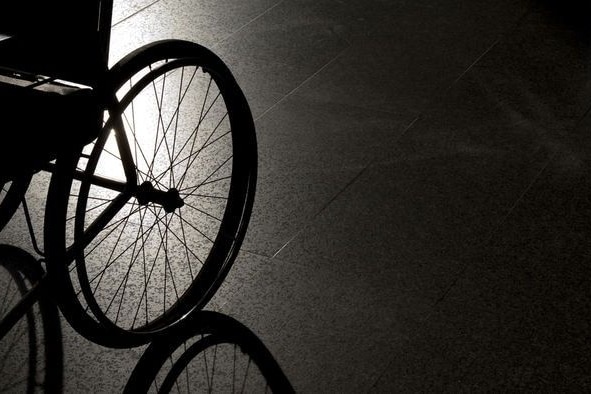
[0,245,63,393]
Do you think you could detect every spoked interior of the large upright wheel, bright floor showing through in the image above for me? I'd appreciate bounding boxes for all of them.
[64,55,248,332]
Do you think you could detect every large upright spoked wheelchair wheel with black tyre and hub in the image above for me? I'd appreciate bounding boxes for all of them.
[45,40,257,347]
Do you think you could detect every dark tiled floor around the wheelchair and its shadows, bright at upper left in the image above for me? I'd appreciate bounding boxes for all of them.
[1,0,591,393]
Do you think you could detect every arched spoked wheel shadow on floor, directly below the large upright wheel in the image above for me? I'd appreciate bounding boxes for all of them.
[124,311,294,393]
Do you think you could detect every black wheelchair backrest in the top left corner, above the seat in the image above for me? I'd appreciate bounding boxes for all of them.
[0,0,113,82]
